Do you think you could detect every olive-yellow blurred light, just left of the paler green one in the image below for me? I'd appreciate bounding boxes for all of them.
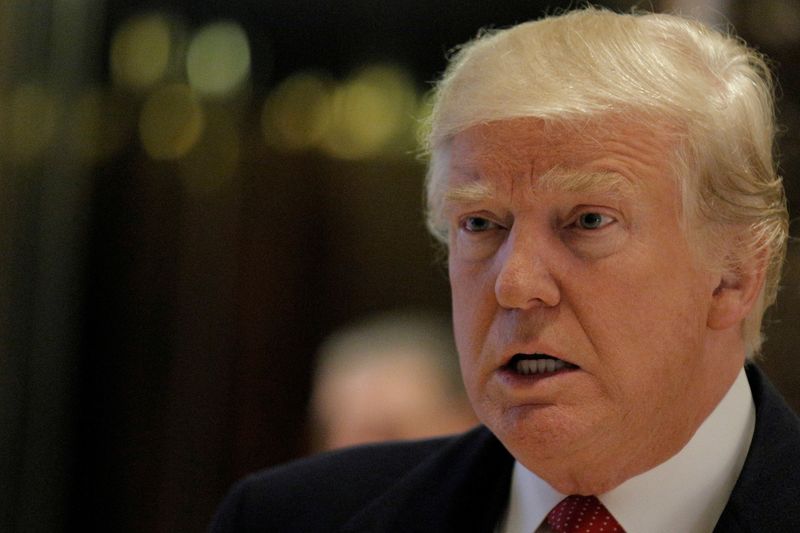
[110,14,173,91]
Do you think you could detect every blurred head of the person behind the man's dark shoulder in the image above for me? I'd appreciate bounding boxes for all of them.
[310,312,476,451]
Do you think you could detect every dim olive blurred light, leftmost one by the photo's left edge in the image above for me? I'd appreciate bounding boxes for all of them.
[3,84,61,161]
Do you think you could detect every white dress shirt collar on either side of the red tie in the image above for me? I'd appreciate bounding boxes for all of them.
[497,369,756,533]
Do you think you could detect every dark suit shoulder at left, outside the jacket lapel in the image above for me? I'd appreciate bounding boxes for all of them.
[206,430,496,532]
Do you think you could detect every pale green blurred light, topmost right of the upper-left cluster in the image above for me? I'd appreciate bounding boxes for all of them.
[186,22,250,96]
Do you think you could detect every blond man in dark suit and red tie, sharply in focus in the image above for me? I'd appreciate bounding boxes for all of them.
[209,9,800,533]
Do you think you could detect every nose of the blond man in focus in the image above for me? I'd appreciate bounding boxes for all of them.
[495,233,561,309]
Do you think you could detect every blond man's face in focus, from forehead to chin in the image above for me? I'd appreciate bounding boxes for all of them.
[444,119,742,494]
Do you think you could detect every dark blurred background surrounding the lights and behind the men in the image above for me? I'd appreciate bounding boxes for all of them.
[0,0,800,532]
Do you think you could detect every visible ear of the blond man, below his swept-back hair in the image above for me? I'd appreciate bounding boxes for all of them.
[707,254,766,330]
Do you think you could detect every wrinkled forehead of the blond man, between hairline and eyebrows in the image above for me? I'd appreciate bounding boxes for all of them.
[446,118,676,200]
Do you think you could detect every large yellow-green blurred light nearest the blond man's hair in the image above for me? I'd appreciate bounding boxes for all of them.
[322,65,416,159]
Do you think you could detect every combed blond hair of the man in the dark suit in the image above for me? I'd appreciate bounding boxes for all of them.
[427,7,788,357]
